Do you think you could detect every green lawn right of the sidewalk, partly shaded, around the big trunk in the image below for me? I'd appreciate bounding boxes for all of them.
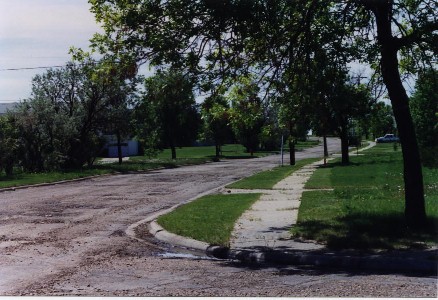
[292,144,438,249]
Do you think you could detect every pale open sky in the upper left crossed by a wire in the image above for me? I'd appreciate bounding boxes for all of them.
[0,0,101,103]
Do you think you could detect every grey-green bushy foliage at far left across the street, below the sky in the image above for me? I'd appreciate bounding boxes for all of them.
[4,54,137,172]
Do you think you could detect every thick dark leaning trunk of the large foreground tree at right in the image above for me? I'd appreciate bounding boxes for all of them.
[374,4,426,228]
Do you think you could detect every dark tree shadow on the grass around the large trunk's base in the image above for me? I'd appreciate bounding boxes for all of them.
[293,213,438,250]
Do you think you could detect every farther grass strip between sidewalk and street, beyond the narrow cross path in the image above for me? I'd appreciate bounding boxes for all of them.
[227,158,321,190]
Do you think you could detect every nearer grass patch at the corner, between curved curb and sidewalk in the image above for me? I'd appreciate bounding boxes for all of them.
[157,193,261,246]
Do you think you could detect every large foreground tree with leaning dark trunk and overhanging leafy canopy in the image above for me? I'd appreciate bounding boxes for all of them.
[90,0,438,227]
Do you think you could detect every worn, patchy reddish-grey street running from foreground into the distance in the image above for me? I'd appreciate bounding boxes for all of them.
[0,139,436,297]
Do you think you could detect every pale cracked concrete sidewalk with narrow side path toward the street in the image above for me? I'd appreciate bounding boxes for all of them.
[226,142,376,251]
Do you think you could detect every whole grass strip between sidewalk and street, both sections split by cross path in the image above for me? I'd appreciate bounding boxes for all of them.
[158,158,320,246]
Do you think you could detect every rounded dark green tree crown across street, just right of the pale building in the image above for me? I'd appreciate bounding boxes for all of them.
[137,69,201,158]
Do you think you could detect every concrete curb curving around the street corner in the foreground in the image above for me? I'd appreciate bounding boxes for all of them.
[131,216,438,275]
